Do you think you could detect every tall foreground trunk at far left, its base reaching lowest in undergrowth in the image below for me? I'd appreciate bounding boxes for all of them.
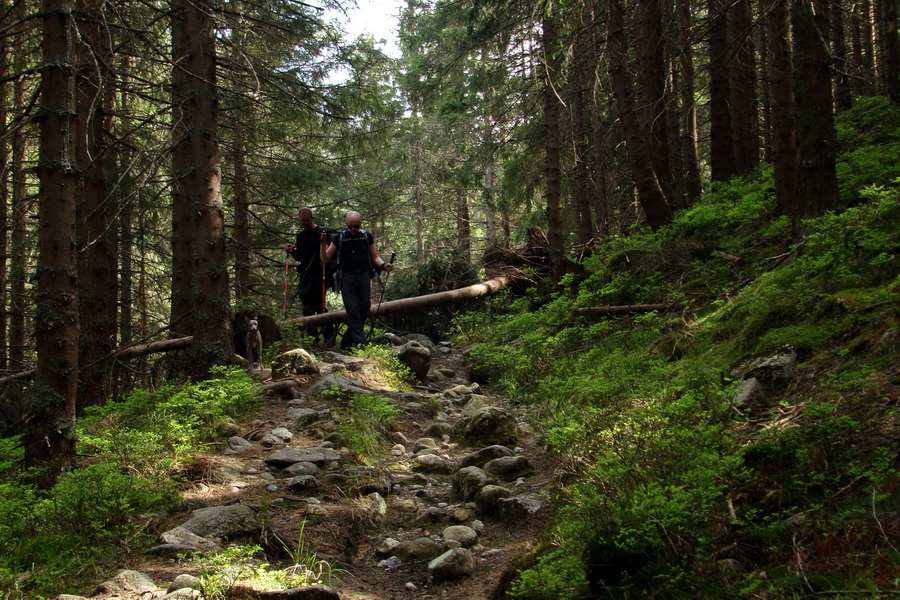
[22,0,78,485]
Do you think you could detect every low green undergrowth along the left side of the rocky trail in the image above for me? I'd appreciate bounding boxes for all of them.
[0,368,260,600]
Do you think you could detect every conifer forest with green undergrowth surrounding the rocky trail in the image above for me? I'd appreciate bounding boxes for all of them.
[0,0,900,600]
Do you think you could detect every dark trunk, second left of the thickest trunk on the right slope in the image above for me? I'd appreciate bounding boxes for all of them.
[727,0,759,175]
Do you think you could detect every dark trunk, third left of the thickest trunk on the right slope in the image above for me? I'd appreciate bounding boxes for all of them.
[708,0,738,181]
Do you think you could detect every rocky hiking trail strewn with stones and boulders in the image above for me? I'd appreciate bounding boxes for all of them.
[58,336,556,600]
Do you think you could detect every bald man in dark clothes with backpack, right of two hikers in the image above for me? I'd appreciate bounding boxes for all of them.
[320,210,394,350]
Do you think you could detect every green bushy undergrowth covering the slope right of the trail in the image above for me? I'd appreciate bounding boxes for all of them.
[457,97,900,599]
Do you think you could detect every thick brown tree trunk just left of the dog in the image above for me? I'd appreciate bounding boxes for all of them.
[173,0,234,378]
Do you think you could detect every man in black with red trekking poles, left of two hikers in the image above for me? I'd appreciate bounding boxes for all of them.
[284,207,336,345]
